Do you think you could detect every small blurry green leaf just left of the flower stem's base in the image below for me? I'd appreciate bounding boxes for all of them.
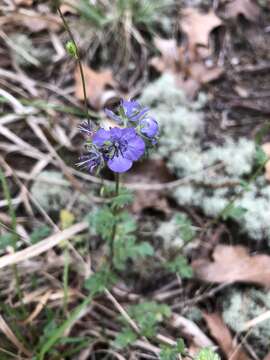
[84,267,117,296]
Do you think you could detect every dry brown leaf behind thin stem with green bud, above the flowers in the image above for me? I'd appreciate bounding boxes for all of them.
[75,65,115,109]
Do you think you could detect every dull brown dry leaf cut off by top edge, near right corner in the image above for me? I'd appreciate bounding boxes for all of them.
[225,0,260,22]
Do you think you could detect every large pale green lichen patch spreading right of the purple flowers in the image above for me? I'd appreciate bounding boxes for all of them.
[140,74,270,244]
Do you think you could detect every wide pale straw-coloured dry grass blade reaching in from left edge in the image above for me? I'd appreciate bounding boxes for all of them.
[0,222,88,269]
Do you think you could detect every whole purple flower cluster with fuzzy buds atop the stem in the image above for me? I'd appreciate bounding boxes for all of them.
[78,100,159,173]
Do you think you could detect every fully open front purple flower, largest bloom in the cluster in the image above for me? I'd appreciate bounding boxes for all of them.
[93,128,145,173]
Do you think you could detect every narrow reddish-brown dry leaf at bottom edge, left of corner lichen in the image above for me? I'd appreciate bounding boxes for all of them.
[203,313,249,360]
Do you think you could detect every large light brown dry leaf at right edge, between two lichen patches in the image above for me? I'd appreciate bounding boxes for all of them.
[192,245,270,287]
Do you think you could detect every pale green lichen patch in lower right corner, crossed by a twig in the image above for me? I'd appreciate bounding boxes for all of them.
[222,288,270,359]
